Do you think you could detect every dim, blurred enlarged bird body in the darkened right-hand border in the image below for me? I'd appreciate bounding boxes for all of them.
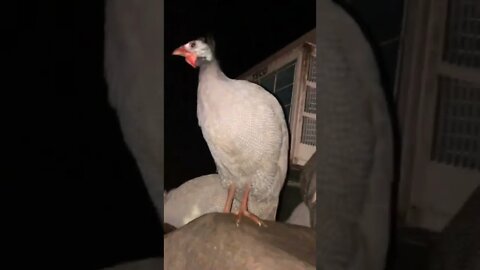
[316,0,394,270]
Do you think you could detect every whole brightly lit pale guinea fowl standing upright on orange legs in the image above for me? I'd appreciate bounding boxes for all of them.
[173,39,288,226]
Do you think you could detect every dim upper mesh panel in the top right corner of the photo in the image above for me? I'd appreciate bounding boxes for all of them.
[443,0,480,67]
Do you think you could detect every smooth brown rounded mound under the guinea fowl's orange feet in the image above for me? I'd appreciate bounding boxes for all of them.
[164,213,316,270]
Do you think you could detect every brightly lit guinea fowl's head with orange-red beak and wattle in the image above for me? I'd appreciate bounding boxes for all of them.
[173,39,214,68]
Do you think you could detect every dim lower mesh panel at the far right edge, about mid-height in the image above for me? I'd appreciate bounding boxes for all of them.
[431,76,480,170]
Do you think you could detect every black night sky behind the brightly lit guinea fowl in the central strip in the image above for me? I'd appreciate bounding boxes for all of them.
[165,0,315,190]
